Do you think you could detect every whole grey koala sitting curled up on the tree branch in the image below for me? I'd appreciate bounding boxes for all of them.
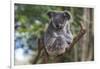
[44,11,73,55]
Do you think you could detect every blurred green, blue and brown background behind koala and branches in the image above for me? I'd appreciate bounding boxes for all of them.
[14,4,94,65]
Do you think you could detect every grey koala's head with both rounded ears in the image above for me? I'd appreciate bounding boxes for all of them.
[48,11,71,29]
